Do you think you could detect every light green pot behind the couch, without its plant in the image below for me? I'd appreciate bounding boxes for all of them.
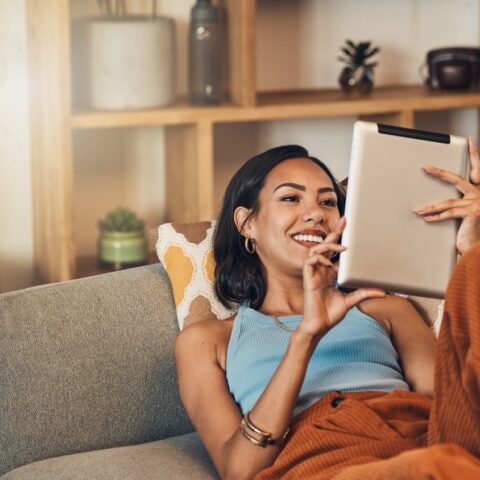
[98,231,148,270]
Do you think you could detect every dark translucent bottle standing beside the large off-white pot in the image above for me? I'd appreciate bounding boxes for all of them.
[188,0,222,105]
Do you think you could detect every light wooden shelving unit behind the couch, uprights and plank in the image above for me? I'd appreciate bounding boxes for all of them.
[27,0,480,282]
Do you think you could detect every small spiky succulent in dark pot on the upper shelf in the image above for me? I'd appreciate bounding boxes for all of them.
[338,40,380,95]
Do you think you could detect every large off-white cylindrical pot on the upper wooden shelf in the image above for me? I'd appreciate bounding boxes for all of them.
[82,16,176,110]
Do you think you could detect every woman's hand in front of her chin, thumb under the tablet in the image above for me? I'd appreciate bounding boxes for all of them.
[298,218,385,336]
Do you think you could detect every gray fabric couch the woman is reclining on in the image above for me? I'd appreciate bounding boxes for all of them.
[0,264,218,480]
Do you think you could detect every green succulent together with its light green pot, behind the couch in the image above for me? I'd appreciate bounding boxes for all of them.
[98,207,148,270]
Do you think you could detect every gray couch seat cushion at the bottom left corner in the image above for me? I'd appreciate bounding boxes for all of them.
[0,433,218,480]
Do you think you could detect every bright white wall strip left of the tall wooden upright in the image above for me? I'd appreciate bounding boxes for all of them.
[0,0,34,291]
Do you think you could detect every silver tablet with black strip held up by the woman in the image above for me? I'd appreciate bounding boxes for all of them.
[337,121,468,298]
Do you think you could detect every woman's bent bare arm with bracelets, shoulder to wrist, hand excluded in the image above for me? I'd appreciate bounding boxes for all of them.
[175,321,318,479]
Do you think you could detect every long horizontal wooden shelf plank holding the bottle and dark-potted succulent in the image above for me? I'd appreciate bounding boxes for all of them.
[72,85,480,129]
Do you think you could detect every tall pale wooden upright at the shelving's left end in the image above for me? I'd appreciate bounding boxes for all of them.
[26,0,75,282]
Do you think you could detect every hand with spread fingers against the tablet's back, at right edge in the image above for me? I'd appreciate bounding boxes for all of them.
[415,137,480,255]
